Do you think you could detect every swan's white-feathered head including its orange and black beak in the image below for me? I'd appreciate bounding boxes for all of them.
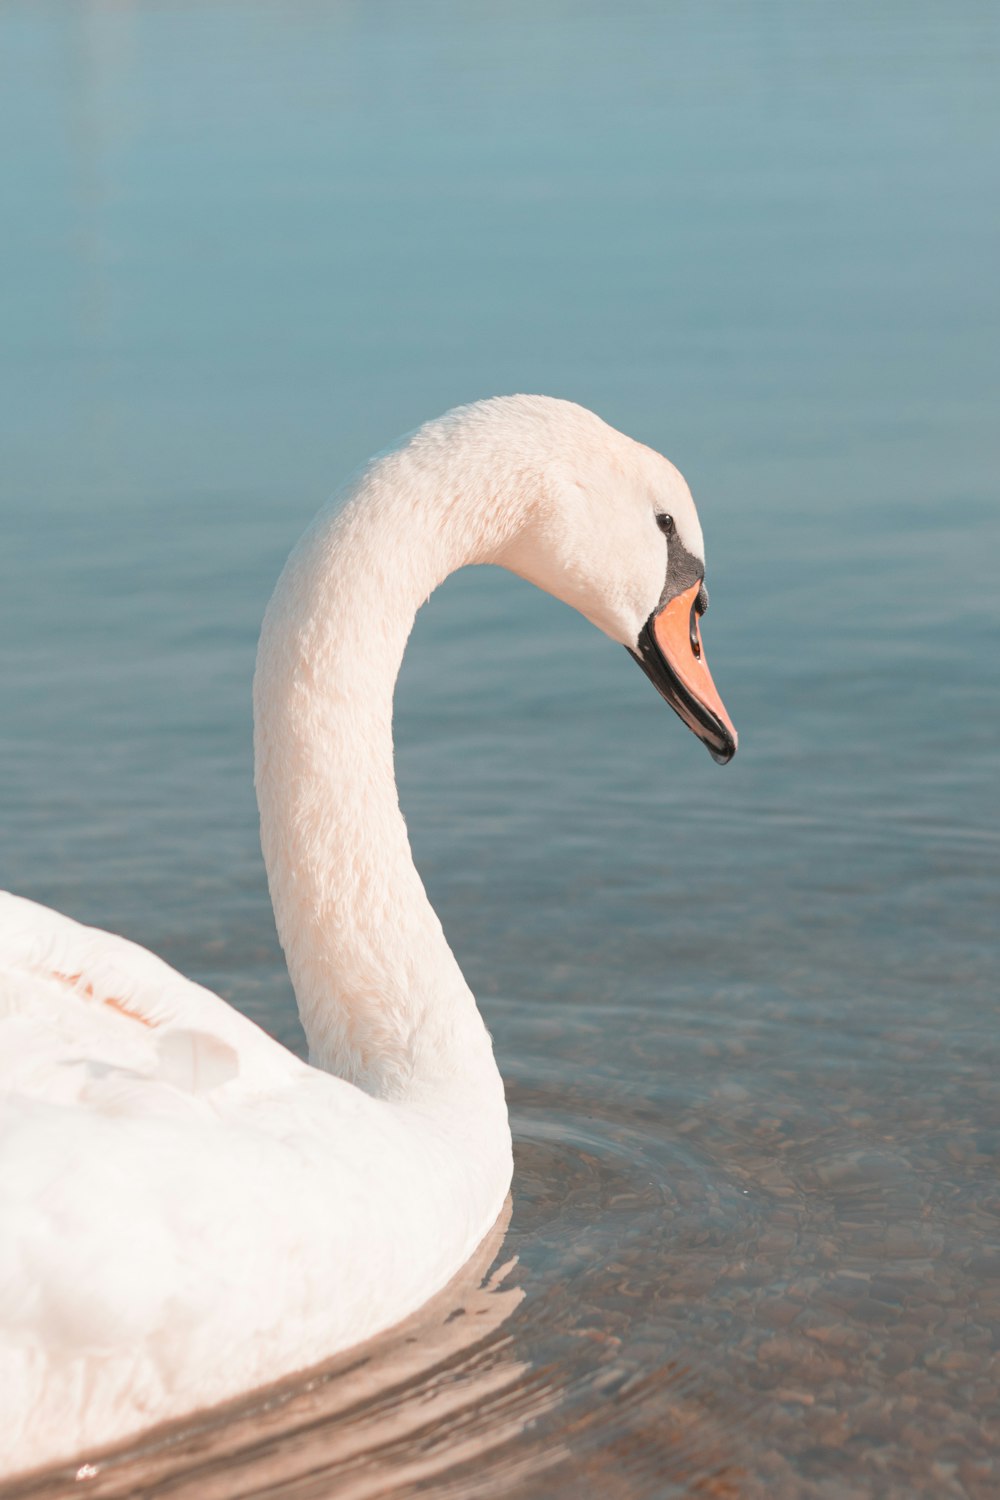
[498,398,738,765]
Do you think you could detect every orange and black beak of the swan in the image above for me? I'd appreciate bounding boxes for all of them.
[631,579,738,765]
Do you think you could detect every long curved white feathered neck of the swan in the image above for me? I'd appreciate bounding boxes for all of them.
[253,420,536,1103]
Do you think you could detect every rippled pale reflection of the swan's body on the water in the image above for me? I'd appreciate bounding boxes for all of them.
[9,1197,535,1500]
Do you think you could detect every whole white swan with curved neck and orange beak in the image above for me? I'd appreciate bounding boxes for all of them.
[0,396,736,1475]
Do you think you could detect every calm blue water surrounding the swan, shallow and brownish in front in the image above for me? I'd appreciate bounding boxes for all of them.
[0,0,1000,1500]
